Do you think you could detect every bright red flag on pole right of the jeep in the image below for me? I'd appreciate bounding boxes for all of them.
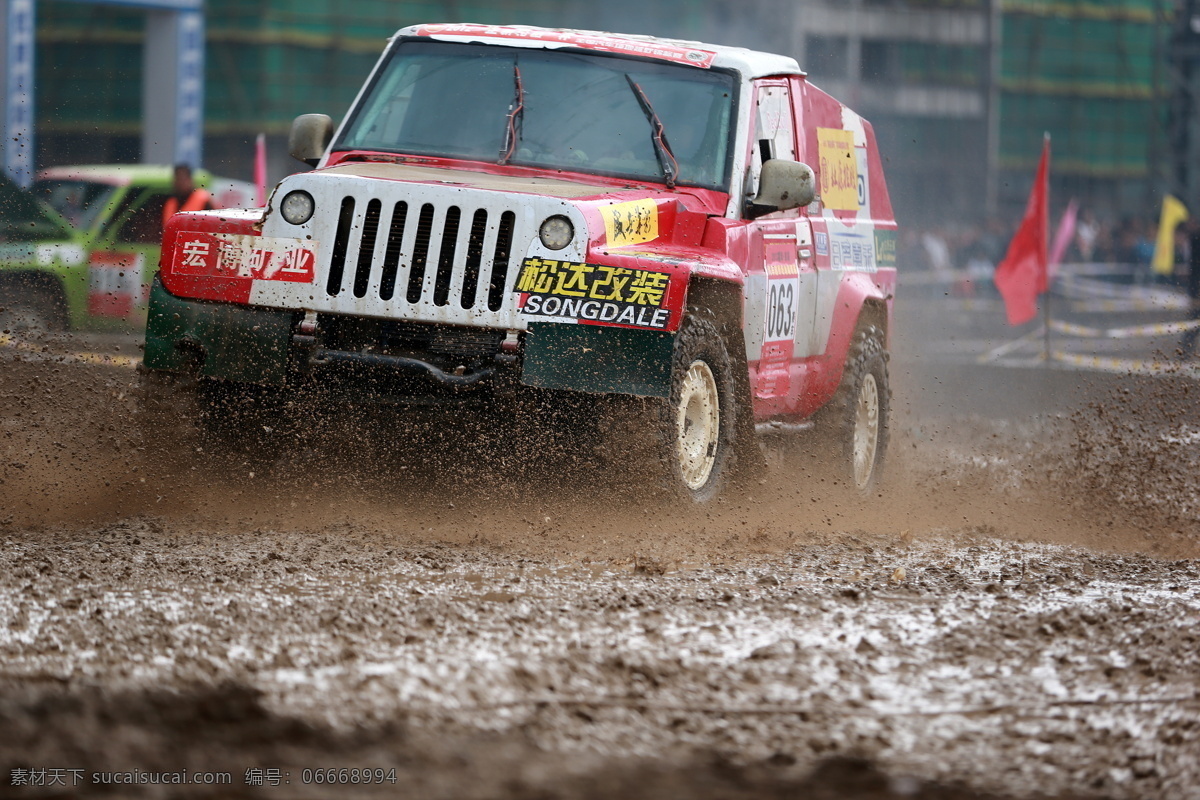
[995,136,1050,325]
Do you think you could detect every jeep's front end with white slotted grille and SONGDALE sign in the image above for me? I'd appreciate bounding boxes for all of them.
[145,163,688,402]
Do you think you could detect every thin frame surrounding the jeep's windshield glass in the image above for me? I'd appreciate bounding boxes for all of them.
[326,36,743,193]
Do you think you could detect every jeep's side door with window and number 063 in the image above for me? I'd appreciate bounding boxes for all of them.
[744,79,815,420]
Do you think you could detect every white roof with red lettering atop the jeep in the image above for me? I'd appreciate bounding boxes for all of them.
[396,23,804,78]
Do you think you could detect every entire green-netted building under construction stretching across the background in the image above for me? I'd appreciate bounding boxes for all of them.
[36,0,1180,224]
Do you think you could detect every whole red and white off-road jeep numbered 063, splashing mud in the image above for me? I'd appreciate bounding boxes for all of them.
[145,25,896,501]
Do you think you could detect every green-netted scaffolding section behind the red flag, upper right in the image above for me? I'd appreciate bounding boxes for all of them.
[998,0,1174,215]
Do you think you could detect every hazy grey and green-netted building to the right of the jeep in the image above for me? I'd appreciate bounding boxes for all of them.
[793,0,1176,222]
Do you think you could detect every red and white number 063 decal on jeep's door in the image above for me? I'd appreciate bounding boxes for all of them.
[756,236,800,397]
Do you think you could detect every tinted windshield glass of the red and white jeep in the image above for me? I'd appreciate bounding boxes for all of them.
[334,41,734,188]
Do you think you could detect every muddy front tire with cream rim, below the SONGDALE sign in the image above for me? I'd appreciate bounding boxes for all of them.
[658,313,738,504]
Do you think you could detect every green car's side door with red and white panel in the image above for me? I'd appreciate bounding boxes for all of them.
[88,187,168,325]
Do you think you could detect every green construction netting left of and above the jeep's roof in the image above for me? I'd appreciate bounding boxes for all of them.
[36,0,712,133]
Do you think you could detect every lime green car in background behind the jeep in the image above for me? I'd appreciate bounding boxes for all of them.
[0,164,254,333]
